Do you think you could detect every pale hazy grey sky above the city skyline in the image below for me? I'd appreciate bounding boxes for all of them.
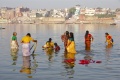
[0,0,120,9]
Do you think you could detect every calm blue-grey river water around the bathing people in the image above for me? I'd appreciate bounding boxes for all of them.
[0,24,120,80]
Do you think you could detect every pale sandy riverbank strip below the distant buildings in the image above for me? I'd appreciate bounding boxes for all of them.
[0,18,115,24]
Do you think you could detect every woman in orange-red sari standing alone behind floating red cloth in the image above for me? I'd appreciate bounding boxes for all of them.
[85,30,94,50]
